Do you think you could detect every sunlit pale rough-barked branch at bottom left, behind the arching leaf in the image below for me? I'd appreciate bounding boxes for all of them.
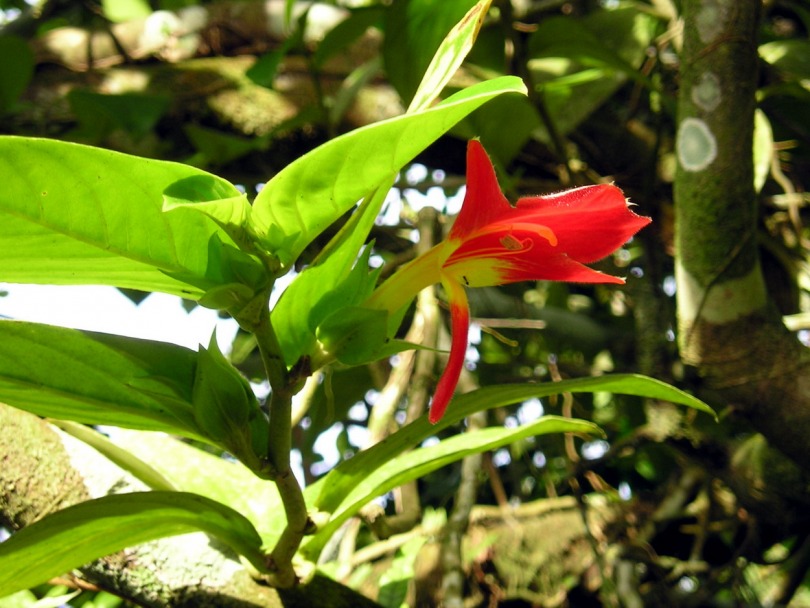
[0,404,378,608]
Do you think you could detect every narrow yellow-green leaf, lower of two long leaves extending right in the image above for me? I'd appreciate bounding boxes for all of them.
[304,416,601,559]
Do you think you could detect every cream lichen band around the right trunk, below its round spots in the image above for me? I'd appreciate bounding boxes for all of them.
[675,261,767,328]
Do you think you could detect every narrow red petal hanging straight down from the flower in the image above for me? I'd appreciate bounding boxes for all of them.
[428,277,470,424]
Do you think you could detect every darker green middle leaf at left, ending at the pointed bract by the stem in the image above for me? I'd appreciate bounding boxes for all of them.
[0,321,204,439]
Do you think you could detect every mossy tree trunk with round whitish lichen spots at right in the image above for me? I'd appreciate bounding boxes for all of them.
[675,0,810,466]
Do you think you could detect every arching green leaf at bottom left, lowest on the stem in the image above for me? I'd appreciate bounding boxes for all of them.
[0,492,266,596]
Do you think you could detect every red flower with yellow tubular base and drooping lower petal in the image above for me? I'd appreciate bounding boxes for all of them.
[368,140,650,423]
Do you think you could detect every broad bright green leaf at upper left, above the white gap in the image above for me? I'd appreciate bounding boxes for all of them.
[0,137,264,299]
